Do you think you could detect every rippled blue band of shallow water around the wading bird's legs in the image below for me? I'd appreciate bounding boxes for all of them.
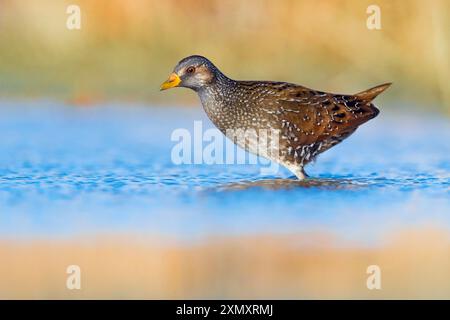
[0,101,450,245]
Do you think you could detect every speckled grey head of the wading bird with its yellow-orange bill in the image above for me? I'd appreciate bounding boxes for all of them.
[161,56,220,91]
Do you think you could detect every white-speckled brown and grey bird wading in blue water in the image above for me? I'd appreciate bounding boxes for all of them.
[160,55,392,180]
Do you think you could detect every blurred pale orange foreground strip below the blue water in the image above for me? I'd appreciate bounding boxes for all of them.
[0,230,450,299]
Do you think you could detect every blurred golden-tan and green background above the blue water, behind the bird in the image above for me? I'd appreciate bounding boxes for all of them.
[0,0,450,113]
